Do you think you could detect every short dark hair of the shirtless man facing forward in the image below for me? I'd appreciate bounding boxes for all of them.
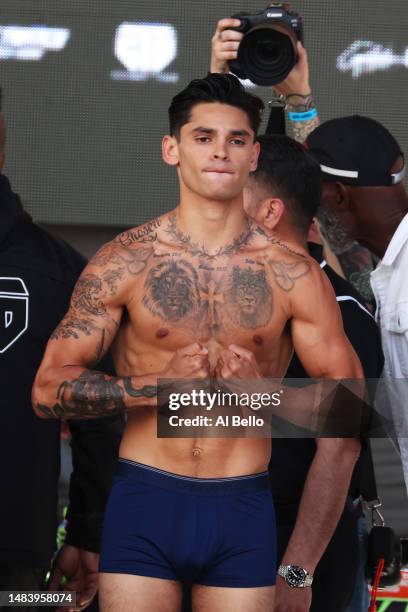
[169,73,265,138]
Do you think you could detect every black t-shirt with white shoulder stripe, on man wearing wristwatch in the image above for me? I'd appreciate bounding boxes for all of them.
[269,253,384,523]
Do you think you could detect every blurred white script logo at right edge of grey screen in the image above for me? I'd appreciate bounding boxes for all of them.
[337,40,408,79]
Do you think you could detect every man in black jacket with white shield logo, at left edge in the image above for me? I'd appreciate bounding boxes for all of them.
[0,100,122,599]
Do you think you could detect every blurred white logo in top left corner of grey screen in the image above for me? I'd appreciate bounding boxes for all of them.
[0,25,70,61]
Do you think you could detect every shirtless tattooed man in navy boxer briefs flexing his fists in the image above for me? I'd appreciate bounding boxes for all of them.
[33,74,361,612]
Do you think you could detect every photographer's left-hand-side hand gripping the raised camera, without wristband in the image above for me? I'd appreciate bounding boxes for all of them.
[210,18,244,74]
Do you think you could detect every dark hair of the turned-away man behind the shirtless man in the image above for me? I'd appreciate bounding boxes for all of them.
[251,134,322,232]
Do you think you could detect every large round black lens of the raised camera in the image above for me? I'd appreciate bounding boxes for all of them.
[238,24,297,85]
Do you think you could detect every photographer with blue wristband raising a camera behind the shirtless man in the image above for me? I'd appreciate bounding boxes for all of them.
[211,9,374,303]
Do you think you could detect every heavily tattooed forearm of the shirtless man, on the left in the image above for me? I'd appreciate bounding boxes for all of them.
[36,370,157,419]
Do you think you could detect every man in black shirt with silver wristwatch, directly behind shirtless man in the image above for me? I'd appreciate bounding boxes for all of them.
[246,136,383,612]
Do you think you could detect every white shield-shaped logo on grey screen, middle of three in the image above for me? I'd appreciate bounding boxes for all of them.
[111,22,179,83]
